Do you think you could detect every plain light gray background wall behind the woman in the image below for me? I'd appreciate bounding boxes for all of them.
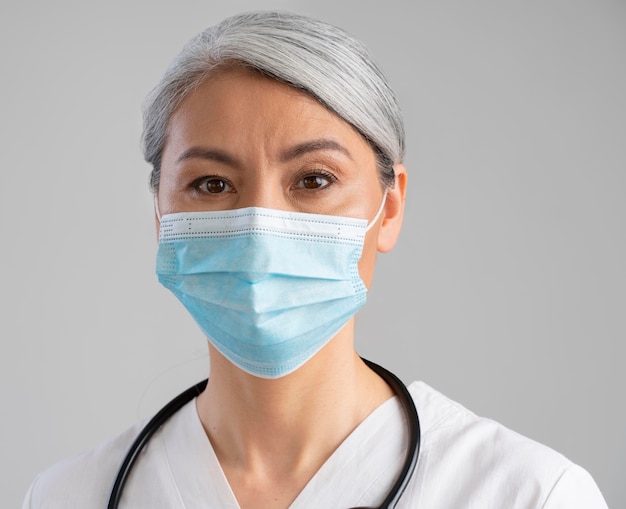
[0,0,626,508]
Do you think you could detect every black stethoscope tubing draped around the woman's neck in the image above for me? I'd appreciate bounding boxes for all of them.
[107,359,420,509]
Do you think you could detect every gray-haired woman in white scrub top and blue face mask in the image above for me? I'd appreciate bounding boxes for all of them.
[24,9,606,509]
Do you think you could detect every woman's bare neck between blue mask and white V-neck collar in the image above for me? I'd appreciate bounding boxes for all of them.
[197,322,393,481]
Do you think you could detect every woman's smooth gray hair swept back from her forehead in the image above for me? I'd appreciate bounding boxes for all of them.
[143,12,404,191]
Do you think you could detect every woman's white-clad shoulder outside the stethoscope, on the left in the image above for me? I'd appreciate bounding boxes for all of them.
[23,416,143,509]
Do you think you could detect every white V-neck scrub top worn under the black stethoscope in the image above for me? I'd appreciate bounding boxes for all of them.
[23,382,607,509]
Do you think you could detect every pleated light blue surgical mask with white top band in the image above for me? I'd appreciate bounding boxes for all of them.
[157,198,385,378]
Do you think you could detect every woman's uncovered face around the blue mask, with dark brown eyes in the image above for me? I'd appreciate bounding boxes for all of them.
[158,69,404,286]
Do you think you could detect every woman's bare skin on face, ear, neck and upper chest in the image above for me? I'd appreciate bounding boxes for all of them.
[157,68,406,509]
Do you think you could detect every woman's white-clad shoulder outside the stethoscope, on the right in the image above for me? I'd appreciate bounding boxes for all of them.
[410,382,606,509]
